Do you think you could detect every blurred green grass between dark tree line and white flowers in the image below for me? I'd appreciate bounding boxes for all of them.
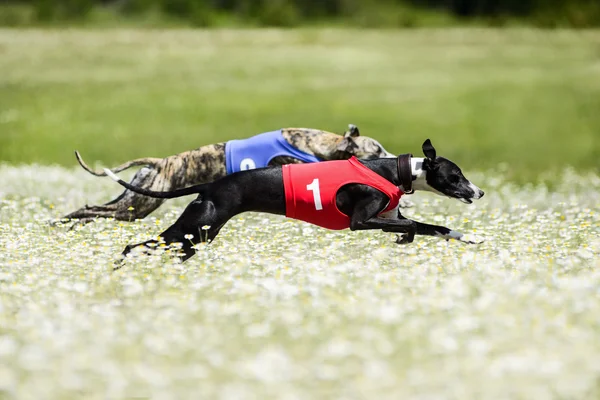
[0,29,600,182]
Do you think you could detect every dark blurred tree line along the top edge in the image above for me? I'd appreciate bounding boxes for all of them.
[0,0,600,28]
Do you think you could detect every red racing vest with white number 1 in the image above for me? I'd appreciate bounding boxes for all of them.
[282,157,404,230]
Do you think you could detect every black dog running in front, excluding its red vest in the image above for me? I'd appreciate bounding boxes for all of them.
[105,139,484,263]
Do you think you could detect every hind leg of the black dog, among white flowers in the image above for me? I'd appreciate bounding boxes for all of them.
[122,199,228,261]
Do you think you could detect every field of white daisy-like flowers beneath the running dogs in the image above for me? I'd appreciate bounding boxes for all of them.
[0,166,600,399]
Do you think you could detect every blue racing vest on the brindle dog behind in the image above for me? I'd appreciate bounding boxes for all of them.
[225,129,321,174]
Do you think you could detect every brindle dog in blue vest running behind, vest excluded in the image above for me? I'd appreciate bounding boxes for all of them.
[63,124,396,223]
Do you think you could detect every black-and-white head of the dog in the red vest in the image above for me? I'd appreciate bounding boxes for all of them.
[415,139,484,204]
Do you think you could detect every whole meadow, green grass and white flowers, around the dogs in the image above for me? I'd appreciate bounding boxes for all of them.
[0,29,600,399]
